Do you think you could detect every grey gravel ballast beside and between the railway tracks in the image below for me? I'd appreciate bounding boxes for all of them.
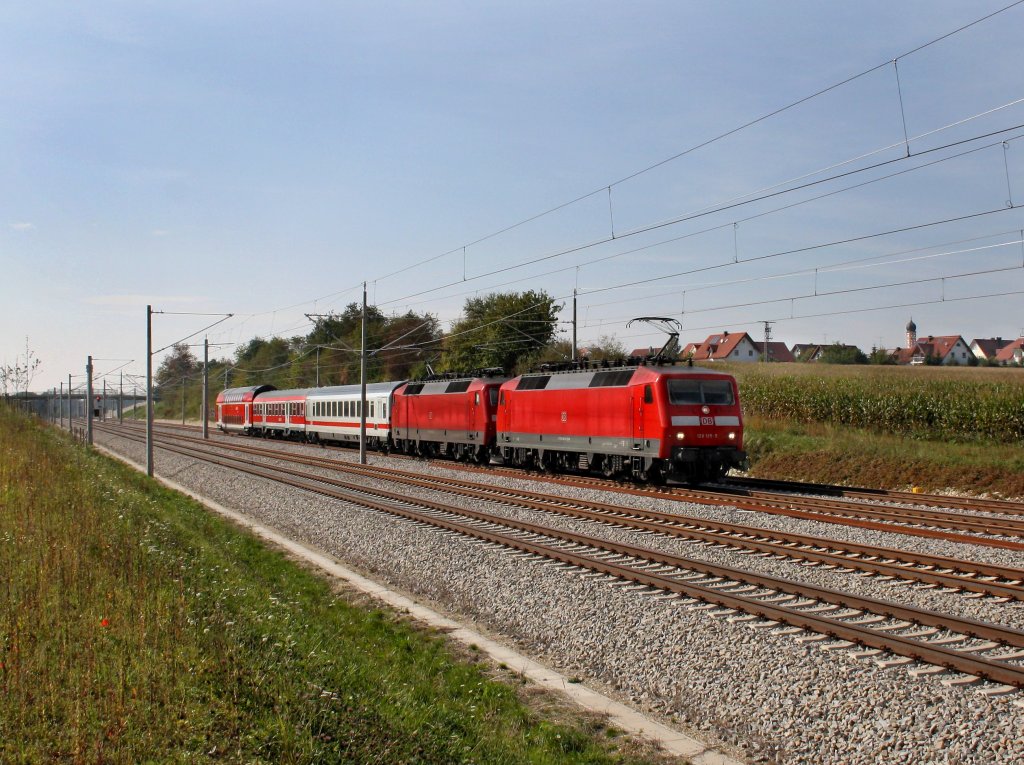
[97,434,1024,765]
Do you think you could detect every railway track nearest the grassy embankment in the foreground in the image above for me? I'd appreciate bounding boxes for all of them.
[94,423,1024,694]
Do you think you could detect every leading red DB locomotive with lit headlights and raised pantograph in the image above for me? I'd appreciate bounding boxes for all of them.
[497,366,746,482]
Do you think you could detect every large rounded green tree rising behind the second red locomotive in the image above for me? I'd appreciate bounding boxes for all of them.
[440,290,560,373]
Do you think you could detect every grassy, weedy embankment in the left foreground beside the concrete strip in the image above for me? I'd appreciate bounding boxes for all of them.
[0,407,671,763]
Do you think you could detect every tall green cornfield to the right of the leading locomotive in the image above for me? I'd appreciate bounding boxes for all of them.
[729,365,1024,443]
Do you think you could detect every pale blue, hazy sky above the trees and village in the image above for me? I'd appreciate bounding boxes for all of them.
[0,0,1024,390]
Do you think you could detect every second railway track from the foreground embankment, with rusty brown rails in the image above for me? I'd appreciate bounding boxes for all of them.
[96,421,1024,600]
